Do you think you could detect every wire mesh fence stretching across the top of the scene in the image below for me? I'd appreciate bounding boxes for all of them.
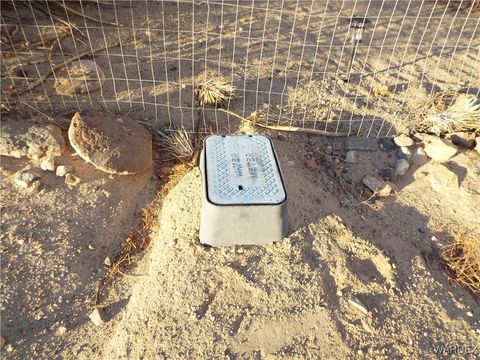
[1,0,480,136]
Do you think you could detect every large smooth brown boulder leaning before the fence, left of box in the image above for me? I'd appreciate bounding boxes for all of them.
[68,112,152,175]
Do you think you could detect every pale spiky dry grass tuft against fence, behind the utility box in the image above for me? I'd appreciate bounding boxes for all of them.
[195,79,237,108]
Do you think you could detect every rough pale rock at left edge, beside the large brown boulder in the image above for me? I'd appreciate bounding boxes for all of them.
[0,120,65,160]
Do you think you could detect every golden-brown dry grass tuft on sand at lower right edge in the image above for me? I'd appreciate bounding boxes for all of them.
[442,235,480,295]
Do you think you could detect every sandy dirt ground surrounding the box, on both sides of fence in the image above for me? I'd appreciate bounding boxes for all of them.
[0,1,480,359]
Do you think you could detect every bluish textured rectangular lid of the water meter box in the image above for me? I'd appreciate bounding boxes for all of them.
[204,135,287,205]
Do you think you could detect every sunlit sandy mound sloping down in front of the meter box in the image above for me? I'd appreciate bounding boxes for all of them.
[104,170,478,359]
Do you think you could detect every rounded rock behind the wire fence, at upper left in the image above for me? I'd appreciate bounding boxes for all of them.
[55,60,105,96]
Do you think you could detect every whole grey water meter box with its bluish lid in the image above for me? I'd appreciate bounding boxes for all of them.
[200,135,288,246]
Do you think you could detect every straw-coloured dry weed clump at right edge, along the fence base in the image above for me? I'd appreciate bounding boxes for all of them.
[419,94,480,136]
